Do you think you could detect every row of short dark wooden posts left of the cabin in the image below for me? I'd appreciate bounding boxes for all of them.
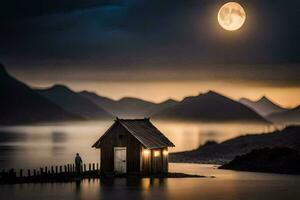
[0,163,99,177]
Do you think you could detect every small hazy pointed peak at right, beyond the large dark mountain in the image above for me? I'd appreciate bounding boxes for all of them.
[239,96,288,117]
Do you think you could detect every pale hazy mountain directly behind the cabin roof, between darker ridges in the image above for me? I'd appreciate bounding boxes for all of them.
[80,91,177,118]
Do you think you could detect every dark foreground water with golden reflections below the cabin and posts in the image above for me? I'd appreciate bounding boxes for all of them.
[0,164,300,200]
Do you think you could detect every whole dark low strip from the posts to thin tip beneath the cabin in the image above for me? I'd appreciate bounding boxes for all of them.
[0,163,214,185]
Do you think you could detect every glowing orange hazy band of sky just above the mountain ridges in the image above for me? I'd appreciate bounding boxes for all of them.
[7,67,300,108]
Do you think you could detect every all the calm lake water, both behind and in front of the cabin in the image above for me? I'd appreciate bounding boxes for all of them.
[0,121,300,200]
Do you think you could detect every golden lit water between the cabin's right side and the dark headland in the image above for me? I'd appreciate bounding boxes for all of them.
[154,121,274,152]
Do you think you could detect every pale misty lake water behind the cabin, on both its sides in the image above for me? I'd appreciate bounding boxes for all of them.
[0,121,272,169]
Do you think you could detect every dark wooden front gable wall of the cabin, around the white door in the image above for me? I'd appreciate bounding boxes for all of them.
[100,123,142,173]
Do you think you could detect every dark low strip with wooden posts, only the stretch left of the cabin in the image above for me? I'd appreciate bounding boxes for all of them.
[0,163,100,184]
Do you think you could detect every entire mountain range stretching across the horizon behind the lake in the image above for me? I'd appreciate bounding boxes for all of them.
[0,65,300,124]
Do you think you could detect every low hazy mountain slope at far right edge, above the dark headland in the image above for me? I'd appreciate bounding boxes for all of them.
[267,106,300,125]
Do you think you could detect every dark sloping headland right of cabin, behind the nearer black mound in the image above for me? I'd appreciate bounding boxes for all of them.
[170,126,300,164]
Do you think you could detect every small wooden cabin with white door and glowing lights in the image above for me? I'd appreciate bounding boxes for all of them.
[93,118,174,174]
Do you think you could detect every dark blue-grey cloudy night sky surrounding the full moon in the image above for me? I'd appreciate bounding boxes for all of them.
[0,0,300,83]
